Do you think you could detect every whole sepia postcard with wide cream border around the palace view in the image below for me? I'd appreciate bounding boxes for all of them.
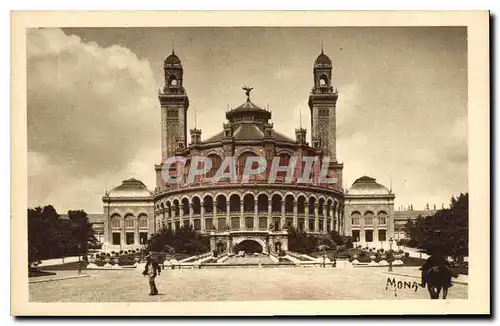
[11,12,490,315]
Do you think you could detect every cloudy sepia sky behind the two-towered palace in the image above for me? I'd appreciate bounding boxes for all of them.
[27,27,468,213]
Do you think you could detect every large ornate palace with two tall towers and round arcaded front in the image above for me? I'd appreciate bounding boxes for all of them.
[96,51,394,253]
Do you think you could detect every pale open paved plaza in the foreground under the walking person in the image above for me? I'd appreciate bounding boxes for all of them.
[29,267,468,302]
